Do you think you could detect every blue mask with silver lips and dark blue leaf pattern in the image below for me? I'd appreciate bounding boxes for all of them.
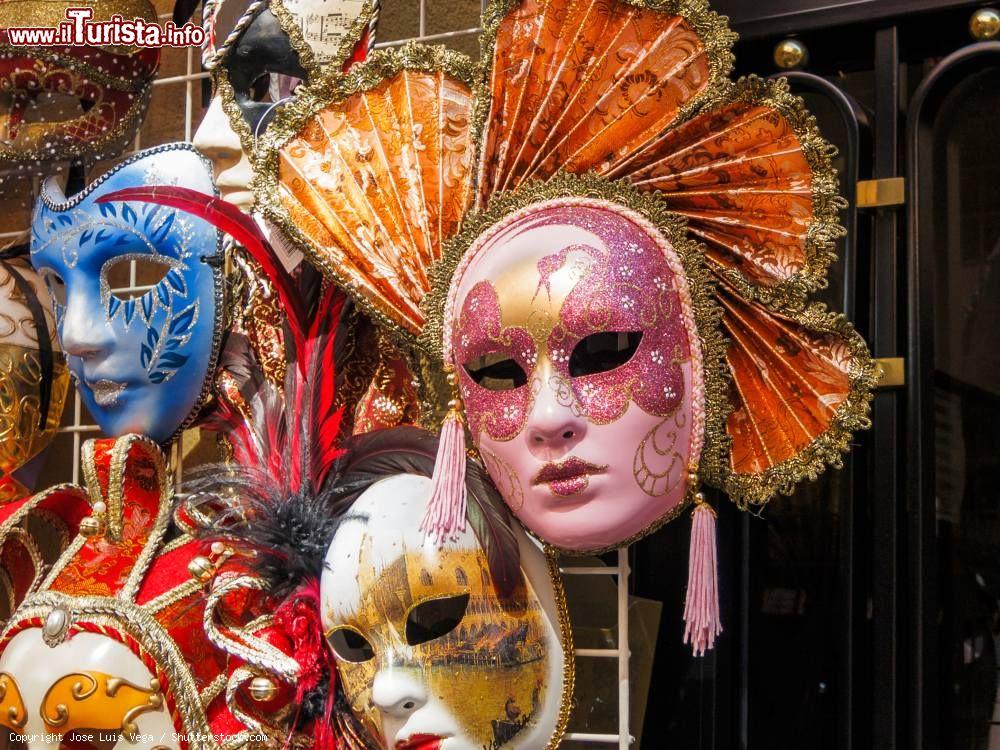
[31,143,222,443]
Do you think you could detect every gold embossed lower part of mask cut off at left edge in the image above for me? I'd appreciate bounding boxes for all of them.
[0,343,69,484]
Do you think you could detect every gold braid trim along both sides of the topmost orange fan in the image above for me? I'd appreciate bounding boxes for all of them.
[472,0,739,169]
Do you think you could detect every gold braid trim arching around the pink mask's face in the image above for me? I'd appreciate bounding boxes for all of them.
[418,173,732,508]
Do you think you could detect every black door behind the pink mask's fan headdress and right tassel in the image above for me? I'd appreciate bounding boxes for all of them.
[633,0,1000,750]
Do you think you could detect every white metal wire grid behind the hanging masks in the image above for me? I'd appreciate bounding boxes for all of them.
[13,0,635,750]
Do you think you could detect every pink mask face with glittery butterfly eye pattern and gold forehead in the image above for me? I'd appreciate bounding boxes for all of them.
[445,198,704,550]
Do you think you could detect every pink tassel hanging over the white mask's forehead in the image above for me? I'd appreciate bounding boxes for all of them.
[420,412,466,544]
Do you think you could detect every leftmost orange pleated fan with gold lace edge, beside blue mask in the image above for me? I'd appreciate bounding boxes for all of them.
[255,46,472,334]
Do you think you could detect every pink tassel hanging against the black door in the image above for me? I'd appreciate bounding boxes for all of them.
[684,495,722,656]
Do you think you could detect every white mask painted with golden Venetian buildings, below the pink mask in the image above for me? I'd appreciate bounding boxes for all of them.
[321,474,567,750]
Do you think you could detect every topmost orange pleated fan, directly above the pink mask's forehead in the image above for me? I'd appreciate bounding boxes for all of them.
[479,0,735,199]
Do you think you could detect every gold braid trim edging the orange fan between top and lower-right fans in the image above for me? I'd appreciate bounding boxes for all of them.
[692,76,847,313]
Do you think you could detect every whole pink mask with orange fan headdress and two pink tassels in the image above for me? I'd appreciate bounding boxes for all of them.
[255,0,876,651]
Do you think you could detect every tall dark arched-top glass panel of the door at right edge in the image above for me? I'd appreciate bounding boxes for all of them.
[920,69,1000,750]
